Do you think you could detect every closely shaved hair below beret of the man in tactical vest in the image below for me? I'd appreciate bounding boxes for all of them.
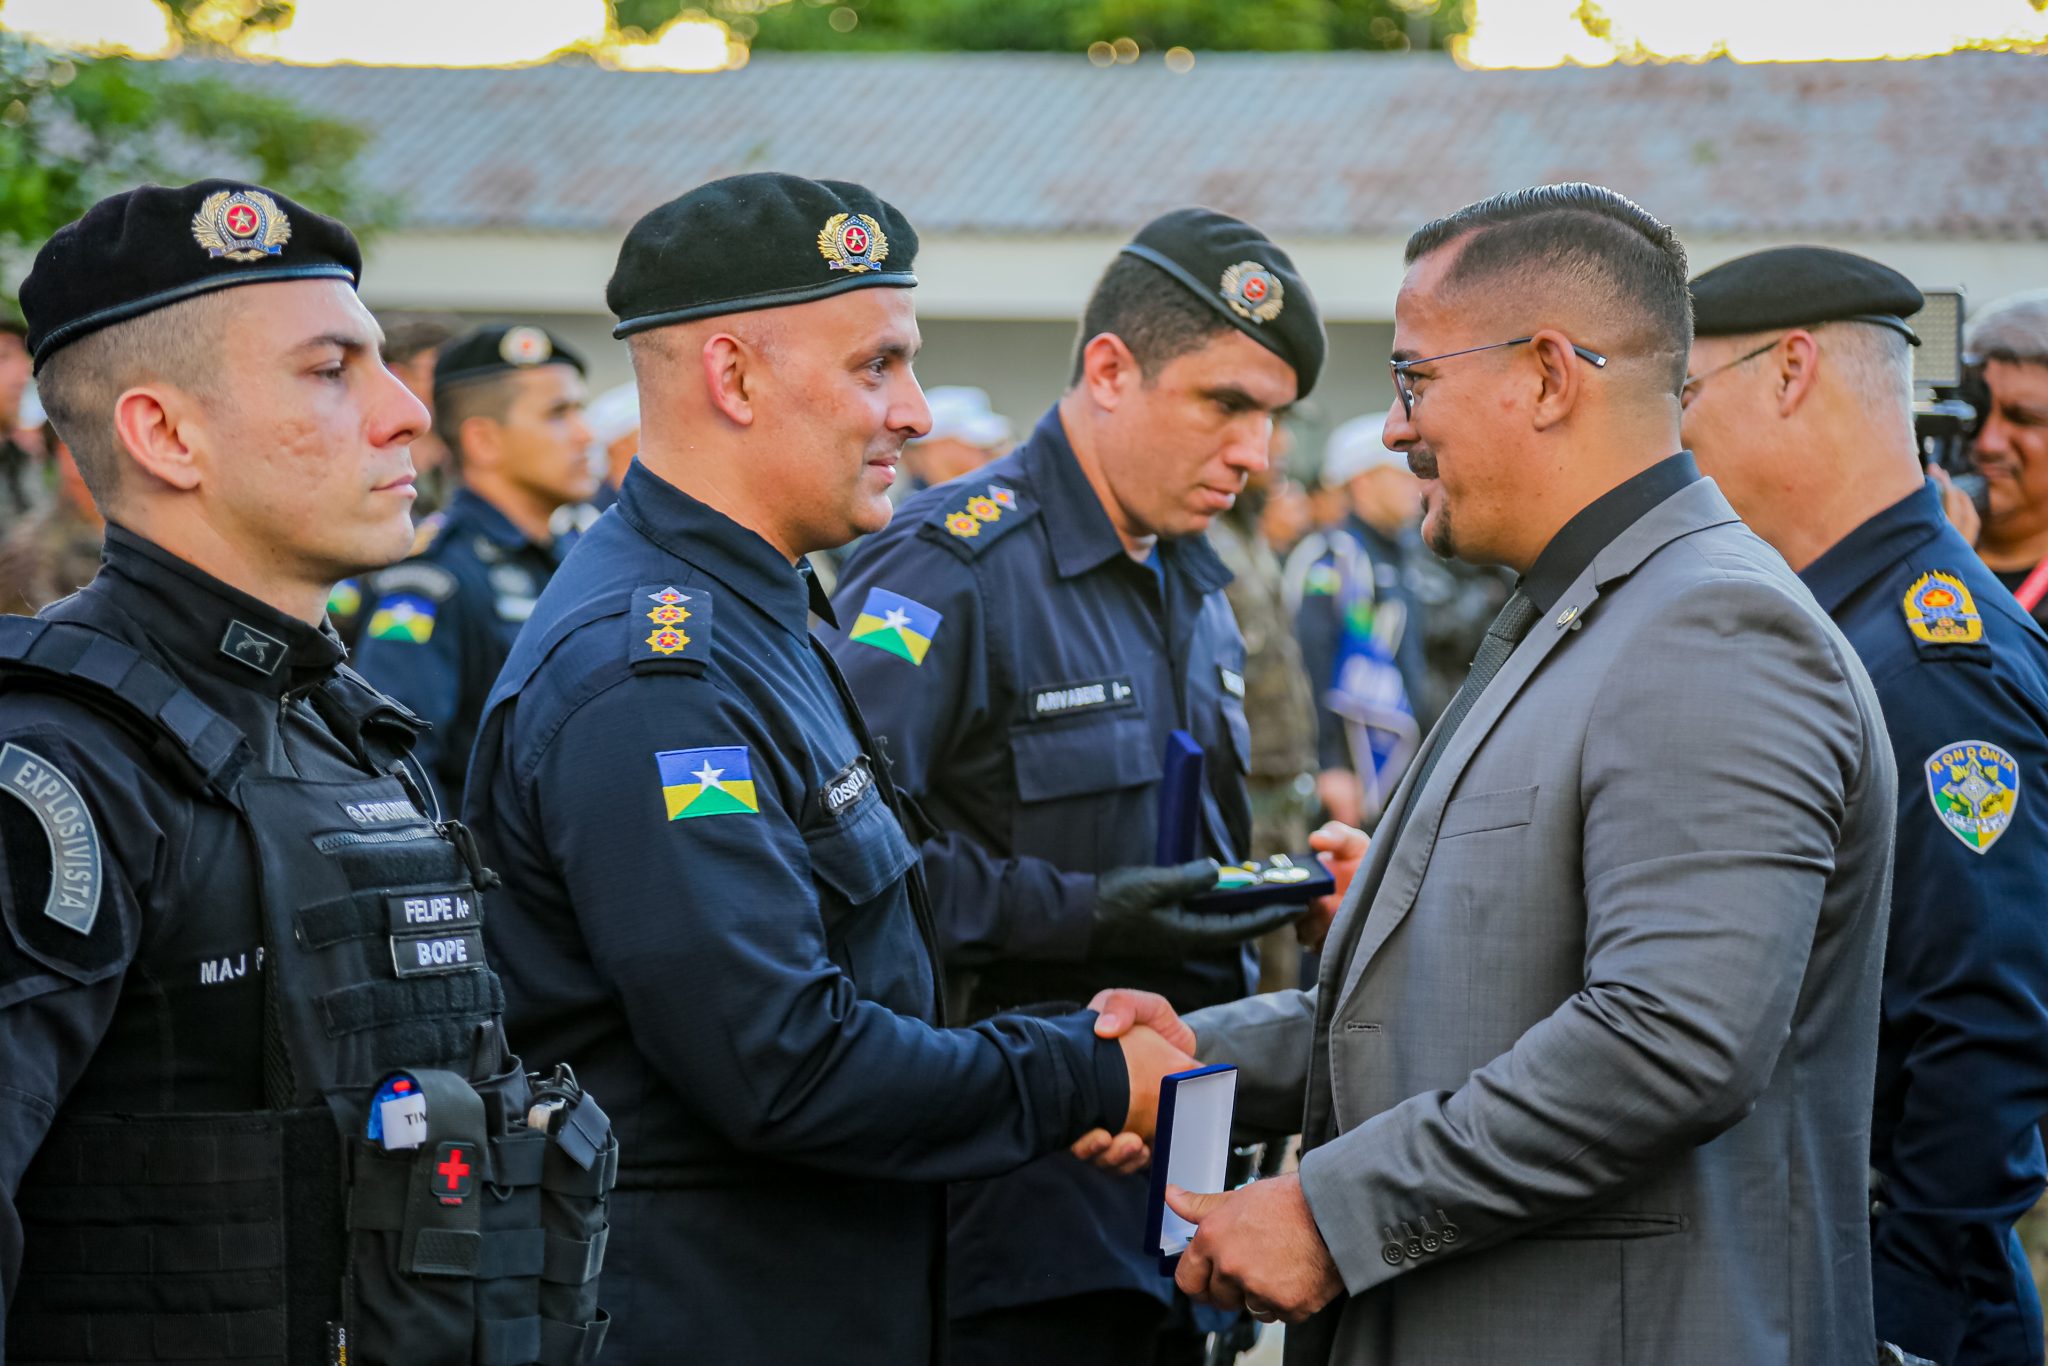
[35,289,227,516]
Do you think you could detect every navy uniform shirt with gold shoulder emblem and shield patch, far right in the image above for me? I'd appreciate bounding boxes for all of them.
[1800,487,2048,1366]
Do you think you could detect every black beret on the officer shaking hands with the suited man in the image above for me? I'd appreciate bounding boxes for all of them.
[604,172,918,336]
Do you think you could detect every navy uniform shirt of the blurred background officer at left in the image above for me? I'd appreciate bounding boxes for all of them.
[354,489,561,815]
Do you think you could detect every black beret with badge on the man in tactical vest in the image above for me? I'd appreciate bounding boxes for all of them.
[20,180,362,369]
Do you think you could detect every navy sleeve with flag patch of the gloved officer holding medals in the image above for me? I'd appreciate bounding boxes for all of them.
[829,530,1096,969]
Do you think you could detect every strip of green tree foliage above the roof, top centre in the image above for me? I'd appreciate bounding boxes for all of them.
[612,0,1473,51]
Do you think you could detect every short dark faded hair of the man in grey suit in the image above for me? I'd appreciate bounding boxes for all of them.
[1407,182,1692,395]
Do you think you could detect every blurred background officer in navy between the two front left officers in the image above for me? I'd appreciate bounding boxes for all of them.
[354,326,598,815]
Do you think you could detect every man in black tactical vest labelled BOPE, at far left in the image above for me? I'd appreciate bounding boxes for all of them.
[0,180,616,1366]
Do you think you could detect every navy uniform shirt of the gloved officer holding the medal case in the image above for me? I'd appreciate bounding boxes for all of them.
[831,408,1255,1315]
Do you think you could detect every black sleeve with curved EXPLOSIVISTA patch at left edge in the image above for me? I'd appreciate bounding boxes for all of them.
[0,717,157,1323]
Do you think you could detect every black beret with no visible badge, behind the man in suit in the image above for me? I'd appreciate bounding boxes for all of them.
[1692,246,1927,346]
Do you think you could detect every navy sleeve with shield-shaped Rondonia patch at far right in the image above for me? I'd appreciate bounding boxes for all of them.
[1872,661,2048,1362]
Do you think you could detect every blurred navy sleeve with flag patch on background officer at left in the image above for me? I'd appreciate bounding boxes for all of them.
[354,565,475,805]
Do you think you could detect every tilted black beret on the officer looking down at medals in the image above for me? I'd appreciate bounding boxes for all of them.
[1124,209,1329,397]
